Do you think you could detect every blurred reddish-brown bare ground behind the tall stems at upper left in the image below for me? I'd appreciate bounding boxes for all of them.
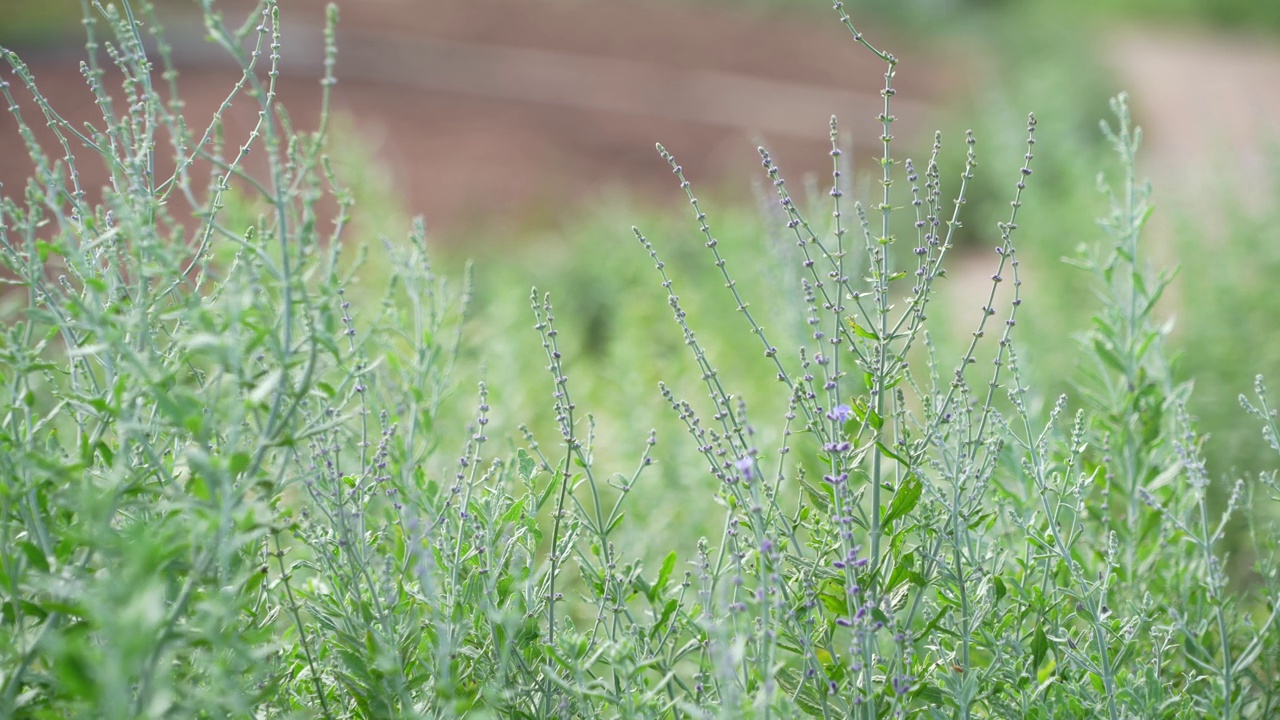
[0,0,957,240]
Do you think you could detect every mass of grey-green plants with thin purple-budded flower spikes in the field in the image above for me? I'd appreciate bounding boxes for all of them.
[0,3,1280,720]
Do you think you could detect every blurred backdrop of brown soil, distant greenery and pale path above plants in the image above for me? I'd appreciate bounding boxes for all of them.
[0,0,1280,233]
